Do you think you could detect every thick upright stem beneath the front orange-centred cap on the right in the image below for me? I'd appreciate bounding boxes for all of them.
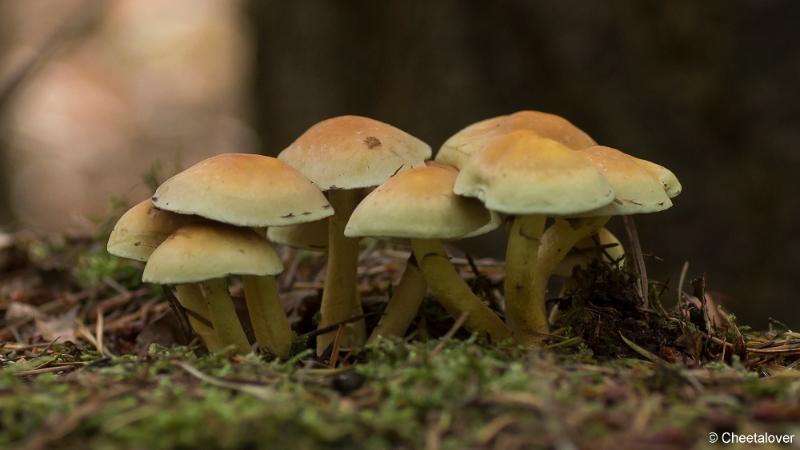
[505,215,548,344]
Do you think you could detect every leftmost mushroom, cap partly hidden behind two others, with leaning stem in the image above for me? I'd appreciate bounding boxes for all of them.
[107,199,221,351]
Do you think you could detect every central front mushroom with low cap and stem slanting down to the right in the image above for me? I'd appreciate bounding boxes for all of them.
[345,164,511,341]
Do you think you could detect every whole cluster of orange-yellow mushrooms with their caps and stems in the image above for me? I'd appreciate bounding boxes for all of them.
[108,111,681,358]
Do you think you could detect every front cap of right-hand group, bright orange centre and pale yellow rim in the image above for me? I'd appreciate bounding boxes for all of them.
[453,130,614,216]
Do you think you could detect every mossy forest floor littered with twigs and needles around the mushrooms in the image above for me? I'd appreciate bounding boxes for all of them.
[0,215,800,449]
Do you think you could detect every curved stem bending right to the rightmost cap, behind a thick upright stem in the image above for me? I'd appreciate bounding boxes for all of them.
[531,216,610,332]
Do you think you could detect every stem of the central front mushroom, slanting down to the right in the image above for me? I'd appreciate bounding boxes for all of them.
[411,239,511,342]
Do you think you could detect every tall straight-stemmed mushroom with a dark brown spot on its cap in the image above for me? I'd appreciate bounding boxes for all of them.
[278,116,431,354]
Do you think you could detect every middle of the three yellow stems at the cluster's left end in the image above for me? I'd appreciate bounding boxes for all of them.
[203,278,250,354]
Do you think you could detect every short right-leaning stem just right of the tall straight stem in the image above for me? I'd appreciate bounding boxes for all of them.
[368,254,428,342]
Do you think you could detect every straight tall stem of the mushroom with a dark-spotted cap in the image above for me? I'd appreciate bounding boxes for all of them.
[317,189,366,355]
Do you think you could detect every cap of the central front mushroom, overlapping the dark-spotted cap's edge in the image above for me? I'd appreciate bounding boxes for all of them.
[344,164,493,239]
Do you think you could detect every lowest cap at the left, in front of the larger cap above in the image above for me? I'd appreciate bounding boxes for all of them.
[142,223,283,284]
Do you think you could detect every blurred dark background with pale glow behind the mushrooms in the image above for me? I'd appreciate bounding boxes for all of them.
[0,0,800,327]
